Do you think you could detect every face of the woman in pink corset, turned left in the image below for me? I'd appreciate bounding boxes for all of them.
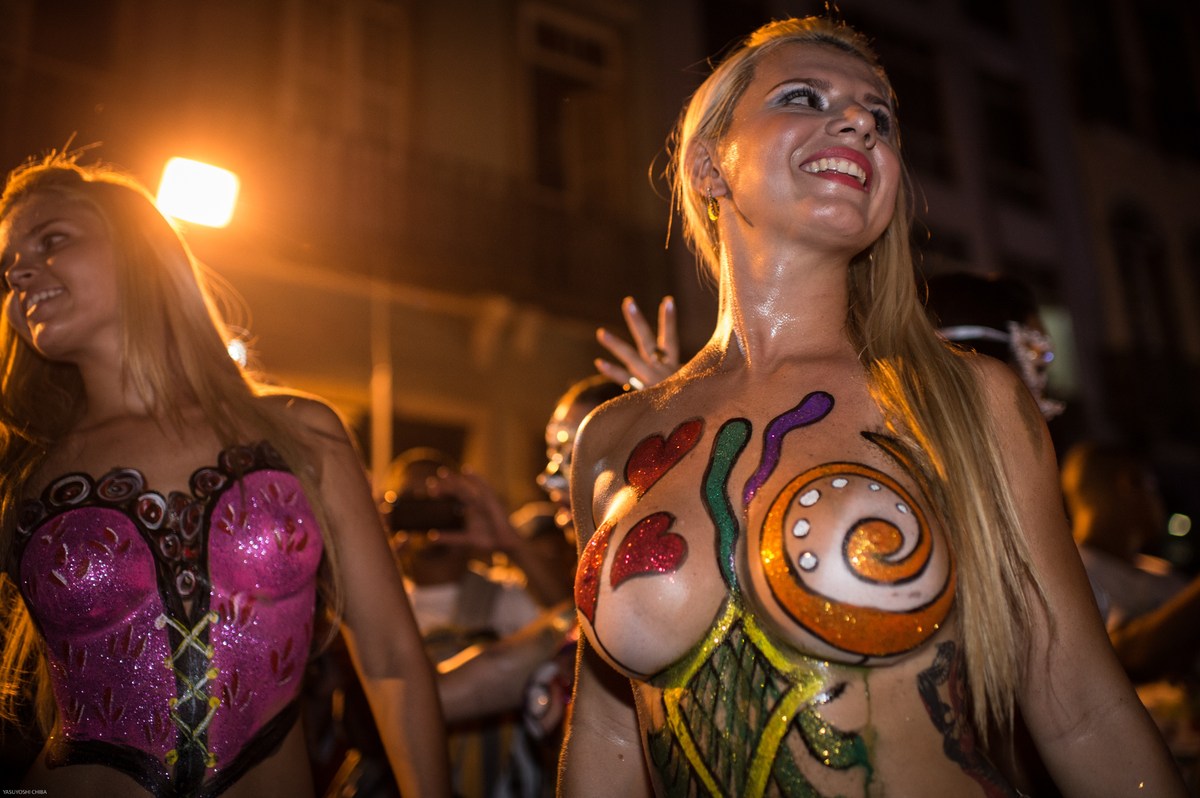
[0,193,120,362]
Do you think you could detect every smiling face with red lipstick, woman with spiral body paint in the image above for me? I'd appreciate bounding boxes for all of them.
[701,43,901,257]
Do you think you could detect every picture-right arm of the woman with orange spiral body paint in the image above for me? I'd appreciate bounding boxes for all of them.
[978,359,1184,797]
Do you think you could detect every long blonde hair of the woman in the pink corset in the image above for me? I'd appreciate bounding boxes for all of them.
[0,154,341,730]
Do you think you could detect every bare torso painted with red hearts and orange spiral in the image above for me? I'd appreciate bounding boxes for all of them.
[576,359,1012,796]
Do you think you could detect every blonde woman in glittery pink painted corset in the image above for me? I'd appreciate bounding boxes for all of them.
[0,155,448,796]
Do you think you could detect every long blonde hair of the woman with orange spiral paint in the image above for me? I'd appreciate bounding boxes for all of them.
[668,17,1044,737]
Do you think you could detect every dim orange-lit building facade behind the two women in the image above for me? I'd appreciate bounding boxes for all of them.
[0,0,1200,528]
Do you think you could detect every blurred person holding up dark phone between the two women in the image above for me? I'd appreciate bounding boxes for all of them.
[385,449,574,798]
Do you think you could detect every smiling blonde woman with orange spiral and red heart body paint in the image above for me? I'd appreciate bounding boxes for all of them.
[560,18,1183,796]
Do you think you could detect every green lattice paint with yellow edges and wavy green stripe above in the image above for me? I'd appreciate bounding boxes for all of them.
[647,408,872,798]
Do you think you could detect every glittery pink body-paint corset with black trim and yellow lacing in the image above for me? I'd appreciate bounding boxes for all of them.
[18,443,323,796]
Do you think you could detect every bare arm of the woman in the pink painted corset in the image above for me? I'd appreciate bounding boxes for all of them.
[283,398,450,796]
